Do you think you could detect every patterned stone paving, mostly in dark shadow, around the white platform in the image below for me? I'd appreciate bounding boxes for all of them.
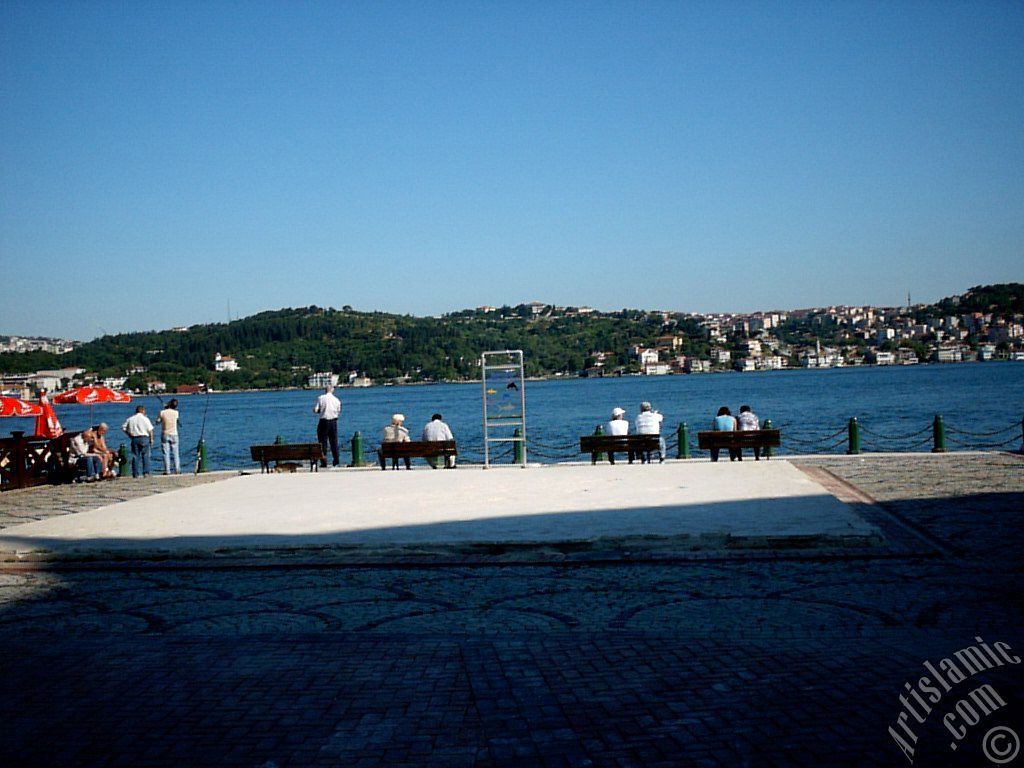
[0,454,1024,768]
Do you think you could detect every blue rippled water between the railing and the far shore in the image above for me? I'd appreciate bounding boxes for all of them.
[3,361,1024,469]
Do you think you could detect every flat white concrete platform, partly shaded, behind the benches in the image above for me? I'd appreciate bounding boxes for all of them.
[0,461,879,555]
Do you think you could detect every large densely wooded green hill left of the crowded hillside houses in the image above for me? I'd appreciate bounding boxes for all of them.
[0,306,702,388]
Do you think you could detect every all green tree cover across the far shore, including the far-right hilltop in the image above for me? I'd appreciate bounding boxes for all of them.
[0,283,1024,390]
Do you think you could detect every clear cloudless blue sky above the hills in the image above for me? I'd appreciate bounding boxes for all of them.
[0,0,1024,339]
